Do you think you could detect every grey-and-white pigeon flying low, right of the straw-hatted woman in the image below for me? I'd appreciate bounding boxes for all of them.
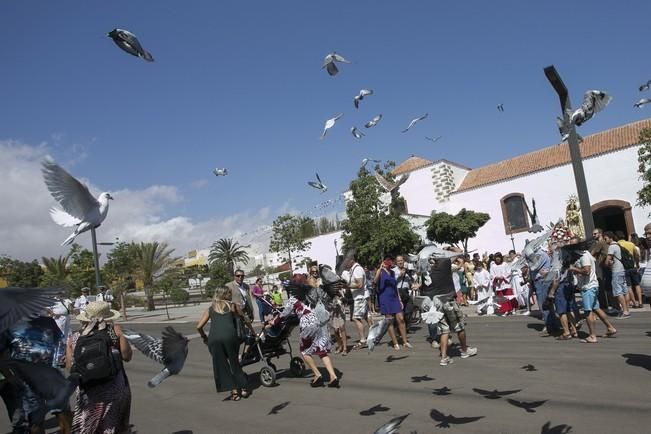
[125,326,188,387]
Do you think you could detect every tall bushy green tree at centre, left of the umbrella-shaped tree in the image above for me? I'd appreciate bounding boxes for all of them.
[341,163,419,265]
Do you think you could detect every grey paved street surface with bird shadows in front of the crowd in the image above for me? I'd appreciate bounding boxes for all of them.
[0,312,651,434]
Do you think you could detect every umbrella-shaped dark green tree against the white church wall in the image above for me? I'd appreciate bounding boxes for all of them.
[425,208,490,252]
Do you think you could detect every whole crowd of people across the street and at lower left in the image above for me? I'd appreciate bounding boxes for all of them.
[0,224,651,433]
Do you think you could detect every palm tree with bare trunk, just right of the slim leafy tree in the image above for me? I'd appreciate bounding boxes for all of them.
[135,241,177,311]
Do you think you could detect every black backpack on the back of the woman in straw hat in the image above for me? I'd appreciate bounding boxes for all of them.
[72,329,122,386]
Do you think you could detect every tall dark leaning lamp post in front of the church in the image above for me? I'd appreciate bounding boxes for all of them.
[545,65,594,239]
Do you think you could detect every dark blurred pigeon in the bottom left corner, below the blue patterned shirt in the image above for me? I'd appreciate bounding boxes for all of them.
[0,359,80,426]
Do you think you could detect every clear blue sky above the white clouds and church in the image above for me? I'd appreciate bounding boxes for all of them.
[0,0,651,258]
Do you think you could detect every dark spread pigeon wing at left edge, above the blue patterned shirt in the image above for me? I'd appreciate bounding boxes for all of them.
[0,287,63,333]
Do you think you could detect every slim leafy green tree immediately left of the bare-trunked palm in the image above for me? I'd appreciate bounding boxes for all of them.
[102,242,138,319]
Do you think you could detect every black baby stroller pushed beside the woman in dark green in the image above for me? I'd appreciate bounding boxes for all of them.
[240,299,305,387]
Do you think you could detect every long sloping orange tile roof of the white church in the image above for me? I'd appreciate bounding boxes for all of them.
[454,119,651,194]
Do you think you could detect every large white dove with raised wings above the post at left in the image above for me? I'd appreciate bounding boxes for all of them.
[42,160,113,246]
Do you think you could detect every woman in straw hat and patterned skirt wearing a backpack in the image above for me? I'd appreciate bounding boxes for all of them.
[66,301,132,434]
